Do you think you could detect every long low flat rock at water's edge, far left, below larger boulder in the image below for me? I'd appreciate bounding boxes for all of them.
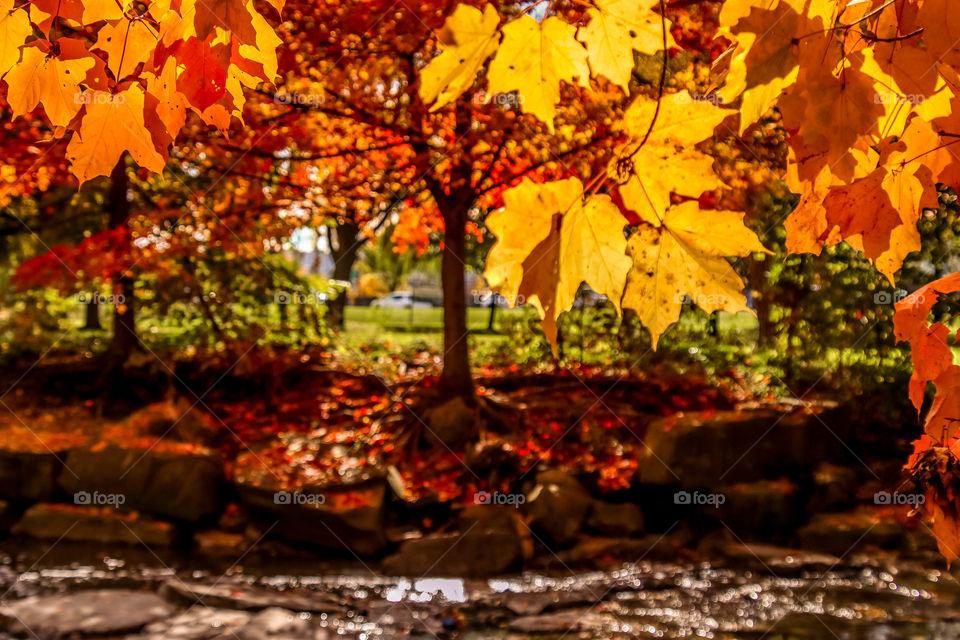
[10,504,177,547]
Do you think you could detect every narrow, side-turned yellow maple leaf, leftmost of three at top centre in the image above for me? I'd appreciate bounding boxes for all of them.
[420,4,500,110]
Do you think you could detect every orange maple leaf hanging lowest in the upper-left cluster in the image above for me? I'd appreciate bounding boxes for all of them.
[67,85,164,184]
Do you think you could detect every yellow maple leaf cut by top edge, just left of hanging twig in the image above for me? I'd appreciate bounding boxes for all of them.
[577,0,676,92]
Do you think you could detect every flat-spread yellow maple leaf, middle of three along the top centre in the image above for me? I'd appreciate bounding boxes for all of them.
[487,16,590,133]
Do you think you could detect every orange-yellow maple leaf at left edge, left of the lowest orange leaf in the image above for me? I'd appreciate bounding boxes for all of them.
[4,47,95,127]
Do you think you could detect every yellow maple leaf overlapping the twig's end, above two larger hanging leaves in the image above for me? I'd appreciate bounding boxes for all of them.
[608,92,731,224]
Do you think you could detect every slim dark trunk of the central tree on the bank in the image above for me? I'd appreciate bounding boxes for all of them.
[435,196,474,398]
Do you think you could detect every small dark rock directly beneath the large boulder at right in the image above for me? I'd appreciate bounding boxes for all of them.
[712,478,806,541]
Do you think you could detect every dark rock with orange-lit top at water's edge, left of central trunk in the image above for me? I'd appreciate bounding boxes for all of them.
[237,478,387,555]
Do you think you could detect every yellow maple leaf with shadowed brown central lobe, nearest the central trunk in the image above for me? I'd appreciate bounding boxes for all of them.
[484,178,630,349]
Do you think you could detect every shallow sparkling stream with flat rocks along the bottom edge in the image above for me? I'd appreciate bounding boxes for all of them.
[0,544,960,640]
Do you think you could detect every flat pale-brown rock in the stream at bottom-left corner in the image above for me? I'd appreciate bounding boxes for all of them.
[0,589,173,638]
